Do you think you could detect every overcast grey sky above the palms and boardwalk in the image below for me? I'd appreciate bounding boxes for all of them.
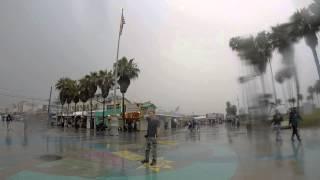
[0,0,320,113]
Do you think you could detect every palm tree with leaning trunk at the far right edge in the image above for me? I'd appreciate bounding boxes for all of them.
[290,9,320,80]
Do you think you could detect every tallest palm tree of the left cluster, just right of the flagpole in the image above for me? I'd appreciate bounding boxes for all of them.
[117,57,140,129]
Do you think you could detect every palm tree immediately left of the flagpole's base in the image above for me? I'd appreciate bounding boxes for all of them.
[98,70,114,124]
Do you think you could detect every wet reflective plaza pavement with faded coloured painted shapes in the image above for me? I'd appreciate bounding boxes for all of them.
[0,121,320,180]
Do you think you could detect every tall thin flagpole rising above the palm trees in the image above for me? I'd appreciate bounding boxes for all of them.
[113,8,123,129]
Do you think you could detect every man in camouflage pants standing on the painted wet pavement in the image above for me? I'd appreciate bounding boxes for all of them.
[141,111,160,166]
